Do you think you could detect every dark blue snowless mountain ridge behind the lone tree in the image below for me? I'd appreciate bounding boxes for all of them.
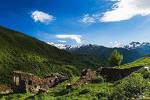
[67,44,144,64]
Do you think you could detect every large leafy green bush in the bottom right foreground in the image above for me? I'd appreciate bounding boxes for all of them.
[112,73,147,99]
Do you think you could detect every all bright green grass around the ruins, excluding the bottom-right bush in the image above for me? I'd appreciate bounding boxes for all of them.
[1,57,150,100]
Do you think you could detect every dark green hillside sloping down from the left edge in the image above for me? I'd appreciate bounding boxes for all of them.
[0,27,100,83]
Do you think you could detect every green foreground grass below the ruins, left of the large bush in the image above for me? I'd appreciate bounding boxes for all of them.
[1,77,113,100]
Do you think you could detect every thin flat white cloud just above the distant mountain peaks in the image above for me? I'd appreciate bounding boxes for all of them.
[56,35,82,43]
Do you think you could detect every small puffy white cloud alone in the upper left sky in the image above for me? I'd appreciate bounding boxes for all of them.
[31,10,55,24]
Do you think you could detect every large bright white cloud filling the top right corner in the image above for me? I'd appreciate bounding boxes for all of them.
[100,0,150,22]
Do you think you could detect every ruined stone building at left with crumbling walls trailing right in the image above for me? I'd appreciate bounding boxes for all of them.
[12,71,67,93]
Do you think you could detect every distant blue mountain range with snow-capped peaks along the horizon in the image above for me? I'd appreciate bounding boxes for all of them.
[48,42,150,63]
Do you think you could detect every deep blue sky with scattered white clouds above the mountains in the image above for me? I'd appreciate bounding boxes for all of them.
[0,0,150,46]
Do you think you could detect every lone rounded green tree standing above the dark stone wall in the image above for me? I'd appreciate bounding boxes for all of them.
[109,50,123,66]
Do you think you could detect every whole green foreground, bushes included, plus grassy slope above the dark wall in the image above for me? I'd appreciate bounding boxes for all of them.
[0,47,150,100]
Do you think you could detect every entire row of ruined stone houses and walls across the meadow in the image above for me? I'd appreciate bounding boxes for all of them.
[4,66,142,94]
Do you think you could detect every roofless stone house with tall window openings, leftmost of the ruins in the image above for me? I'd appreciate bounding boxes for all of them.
[12,71,48,93]
